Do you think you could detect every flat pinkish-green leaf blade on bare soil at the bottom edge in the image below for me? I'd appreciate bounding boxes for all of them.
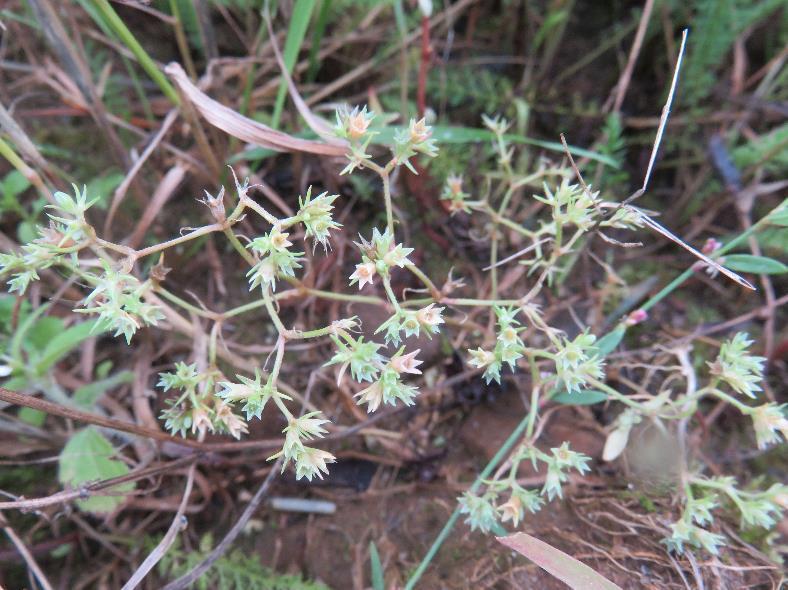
[497,533,621,590]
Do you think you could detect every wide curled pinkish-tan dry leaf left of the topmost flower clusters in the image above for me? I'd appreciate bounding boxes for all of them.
[164,62,347,156]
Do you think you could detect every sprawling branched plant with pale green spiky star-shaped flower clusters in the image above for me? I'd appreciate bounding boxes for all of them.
[0,98,786,551]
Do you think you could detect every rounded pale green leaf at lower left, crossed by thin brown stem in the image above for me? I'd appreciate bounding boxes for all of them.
[58,426,134,512]
